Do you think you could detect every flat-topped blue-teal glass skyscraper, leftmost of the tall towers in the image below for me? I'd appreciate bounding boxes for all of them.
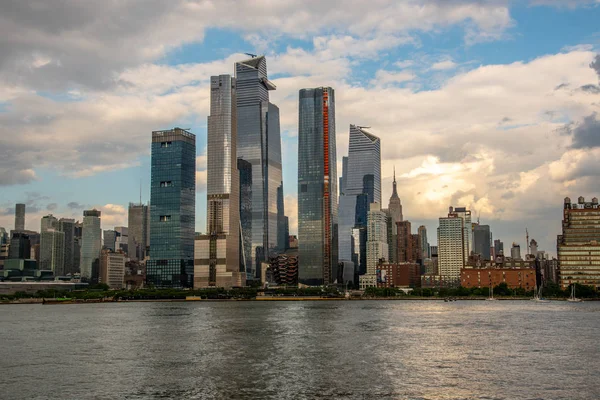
[146,128,196,288]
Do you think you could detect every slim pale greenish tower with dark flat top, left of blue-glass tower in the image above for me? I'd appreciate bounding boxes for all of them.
[79,210,102,282]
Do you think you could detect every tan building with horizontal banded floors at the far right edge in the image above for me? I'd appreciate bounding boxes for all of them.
[557,197,600,289]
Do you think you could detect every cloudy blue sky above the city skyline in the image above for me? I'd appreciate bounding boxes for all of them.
[0,0,600,254]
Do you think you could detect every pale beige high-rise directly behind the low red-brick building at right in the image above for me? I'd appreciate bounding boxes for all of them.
[438,207,471,280]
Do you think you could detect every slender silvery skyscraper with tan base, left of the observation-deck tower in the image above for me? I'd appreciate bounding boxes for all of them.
[194,75,246,288]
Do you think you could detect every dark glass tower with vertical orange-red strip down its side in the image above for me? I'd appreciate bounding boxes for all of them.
[298,87,338,285]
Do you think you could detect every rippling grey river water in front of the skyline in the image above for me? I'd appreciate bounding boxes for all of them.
[0,301,600,400]
